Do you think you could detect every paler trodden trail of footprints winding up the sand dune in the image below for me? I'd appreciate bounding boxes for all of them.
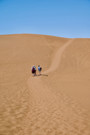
[24,39,90,135]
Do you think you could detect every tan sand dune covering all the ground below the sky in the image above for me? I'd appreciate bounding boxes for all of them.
[0,34,90,135]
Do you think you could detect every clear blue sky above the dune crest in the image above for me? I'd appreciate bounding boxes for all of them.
[0,0,90,38]
